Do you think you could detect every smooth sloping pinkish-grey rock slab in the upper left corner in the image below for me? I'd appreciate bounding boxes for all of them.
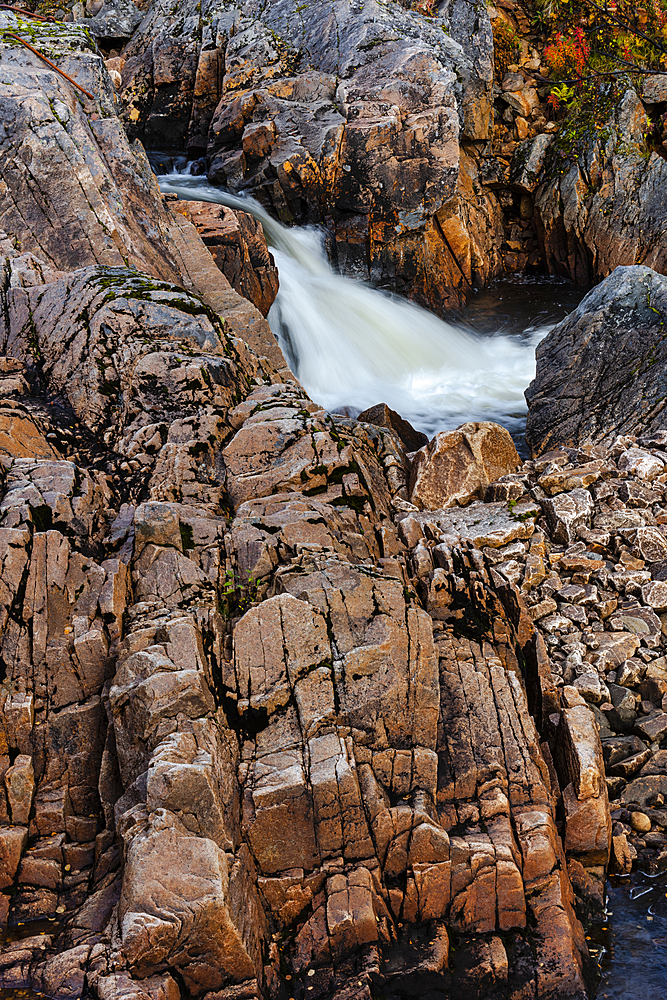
[0,12,285,378]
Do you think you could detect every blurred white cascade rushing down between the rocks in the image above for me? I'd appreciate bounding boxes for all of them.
[160,174,549,437]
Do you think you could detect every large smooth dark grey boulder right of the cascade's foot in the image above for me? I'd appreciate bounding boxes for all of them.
[526,266,667,454]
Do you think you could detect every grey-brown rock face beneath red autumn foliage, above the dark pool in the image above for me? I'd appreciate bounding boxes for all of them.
[534,86,667,285]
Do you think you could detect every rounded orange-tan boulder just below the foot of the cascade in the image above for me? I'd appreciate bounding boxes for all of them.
[410,421,520,510]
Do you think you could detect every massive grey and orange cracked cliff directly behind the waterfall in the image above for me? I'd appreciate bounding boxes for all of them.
[122,0,502,311]
